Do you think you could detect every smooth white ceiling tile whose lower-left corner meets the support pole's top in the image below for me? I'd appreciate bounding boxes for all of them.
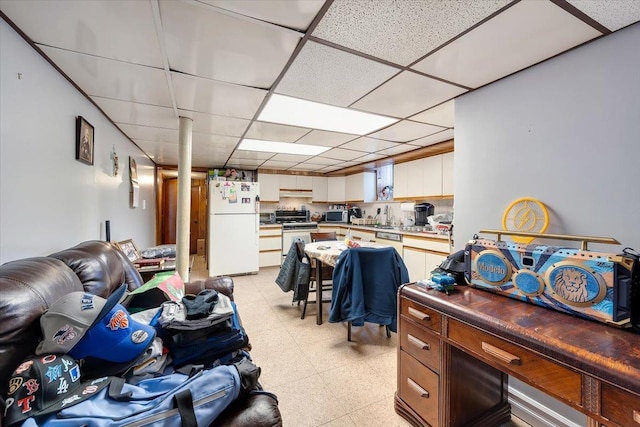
[171,72,267,119]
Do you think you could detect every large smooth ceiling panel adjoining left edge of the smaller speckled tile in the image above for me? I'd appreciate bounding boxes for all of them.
[160,0,301,89]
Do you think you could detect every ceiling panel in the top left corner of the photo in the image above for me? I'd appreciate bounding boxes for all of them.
[2,0,162,67]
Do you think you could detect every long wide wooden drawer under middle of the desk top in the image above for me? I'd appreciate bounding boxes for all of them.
[449,319,582,406]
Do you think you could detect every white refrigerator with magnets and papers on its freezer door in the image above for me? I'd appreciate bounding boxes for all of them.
[208,181,260,277]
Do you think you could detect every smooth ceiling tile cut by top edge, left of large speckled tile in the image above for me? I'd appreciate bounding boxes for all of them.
[200,0,325,30]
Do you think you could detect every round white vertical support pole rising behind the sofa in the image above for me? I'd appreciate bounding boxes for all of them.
[176,117,193,282]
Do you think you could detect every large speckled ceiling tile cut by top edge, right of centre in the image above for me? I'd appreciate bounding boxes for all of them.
[313,0,510,65]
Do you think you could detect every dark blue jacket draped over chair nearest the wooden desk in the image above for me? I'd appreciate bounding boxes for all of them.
[329,247,409,332]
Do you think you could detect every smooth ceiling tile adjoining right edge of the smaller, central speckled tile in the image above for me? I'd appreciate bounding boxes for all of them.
[352,71,467,117]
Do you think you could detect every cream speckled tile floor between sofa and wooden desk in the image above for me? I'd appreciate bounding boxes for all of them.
[191,259,527,427]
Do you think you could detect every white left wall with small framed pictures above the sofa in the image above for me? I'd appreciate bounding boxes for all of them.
[0,20,155,263]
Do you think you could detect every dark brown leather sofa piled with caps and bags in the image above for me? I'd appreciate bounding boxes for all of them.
[0,240,282,427]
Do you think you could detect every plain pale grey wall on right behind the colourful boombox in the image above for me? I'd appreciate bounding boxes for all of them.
[454,24,640,425]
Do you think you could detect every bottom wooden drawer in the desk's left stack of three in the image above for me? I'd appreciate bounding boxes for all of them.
[399,351,439,427]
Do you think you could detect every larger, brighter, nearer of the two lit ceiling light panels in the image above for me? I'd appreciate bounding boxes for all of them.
[258,94,398,135]
